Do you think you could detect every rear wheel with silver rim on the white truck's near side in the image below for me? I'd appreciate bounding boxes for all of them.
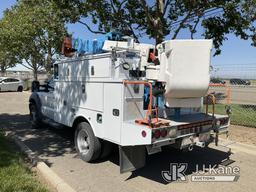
[75,122,101,162]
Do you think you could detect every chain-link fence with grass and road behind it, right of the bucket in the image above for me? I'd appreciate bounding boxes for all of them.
[208,64,256,128]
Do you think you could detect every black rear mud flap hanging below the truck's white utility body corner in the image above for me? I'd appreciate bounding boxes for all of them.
[119,146,146,173]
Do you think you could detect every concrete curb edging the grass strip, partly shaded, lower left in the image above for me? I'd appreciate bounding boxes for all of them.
[6,131,76,192]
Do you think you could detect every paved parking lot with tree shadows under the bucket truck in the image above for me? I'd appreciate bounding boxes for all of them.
[0,92,256,192]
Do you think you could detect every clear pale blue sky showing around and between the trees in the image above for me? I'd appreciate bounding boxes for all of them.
[0,0,256,78]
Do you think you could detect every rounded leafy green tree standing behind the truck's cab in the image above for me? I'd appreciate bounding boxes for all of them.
[0,0,66,79]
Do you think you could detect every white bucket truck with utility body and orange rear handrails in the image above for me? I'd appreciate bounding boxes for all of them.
[29,39,230,173]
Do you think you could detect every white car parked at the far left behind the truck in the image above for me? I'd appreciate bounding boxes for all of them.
[0,77,24,92]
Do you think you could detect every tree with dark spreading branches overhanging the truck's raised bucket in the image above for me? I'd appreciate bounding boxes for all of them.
[54,0,256,54]
